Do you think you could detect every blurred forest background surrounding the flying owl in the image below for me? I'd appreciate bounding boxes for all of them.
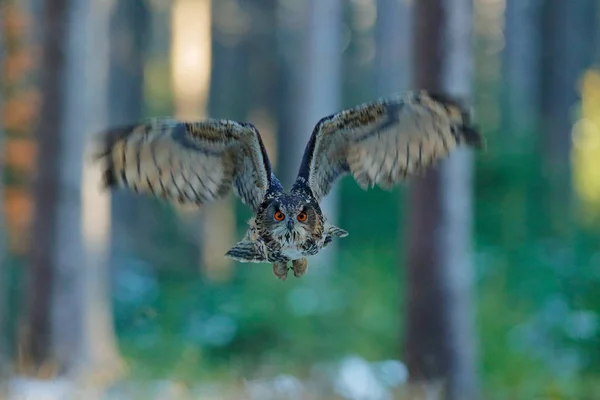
[0,0,600,400]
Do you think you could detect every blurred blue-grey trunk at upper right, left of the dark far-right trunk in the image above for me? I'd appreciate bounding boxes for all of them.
[502,0,542,140]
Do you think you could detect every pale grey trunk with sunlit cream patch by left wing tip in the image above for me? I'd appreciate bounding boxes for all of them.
[52,0,121,383]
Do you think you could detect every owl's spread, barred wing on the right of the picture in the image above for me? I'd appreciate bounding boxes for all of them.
[295,91,484,201]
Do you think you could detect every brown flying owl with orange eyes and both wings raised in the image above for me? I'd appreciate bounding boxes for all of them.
[96,91,484,280]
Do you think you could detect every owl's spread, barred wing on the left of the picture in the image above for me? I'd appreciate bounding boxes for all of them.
[96,118,271,210]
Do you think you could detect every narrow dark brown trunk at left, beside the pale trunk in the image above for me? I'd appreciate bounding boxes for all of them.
[27,0,70,367]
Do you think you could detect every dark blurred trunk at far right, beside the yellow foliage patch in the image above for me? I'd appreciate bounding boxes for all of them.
[539,0,598,236]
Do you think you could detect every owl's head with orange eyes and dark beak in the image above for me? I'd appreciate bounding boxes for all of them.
[257,192,323,244]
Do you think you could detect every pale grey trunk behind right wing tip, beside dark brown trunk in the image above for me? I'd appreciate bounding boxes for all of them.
[439,0,477,400]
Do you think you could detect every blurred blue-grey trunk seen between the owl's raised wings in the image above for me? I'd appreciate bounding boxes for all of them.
[277,0,343,265]
